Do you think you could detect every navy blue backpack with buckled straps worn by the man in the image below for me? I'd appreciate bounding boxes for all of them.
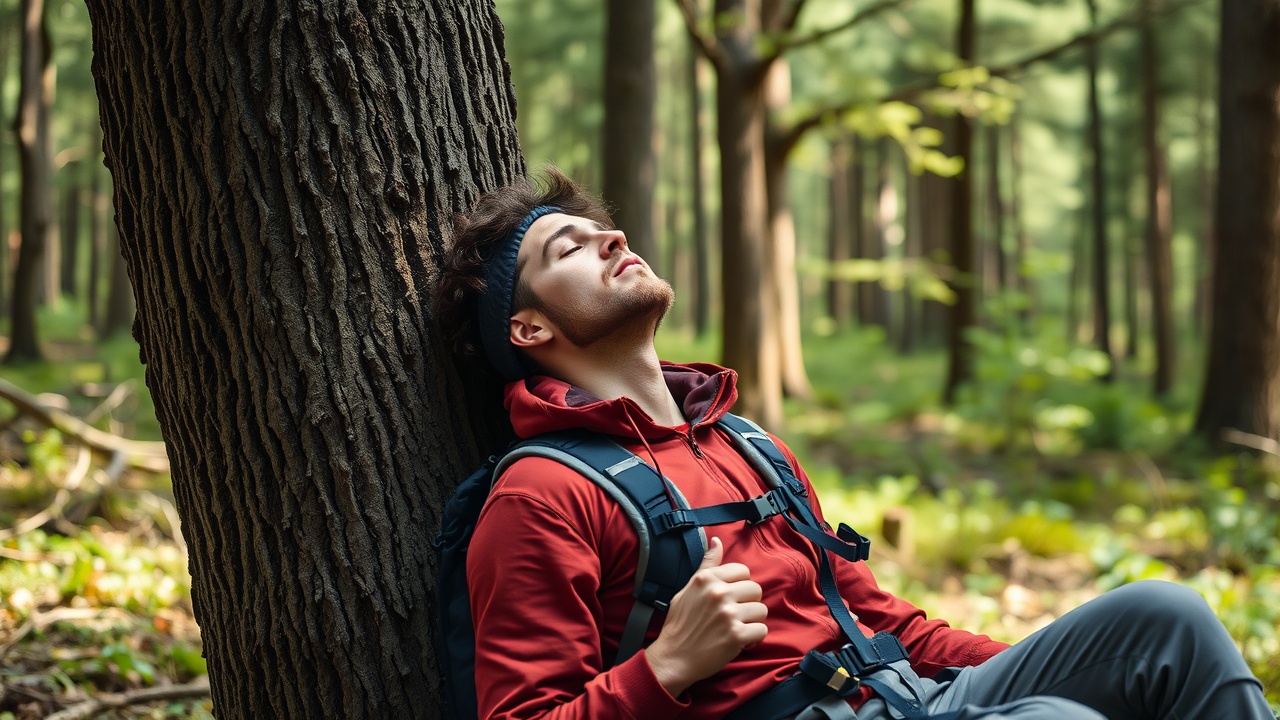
[435,414,920,720]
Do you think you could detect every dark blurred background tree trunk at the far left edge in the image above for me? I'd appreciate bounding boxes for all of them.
[5,0,54,363]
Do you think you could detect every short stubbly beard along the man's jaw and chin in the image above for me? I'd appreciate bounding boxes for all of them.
[539,275,676,347]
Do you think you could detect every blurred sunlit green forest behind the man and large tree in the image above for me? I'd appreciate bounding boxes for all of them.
[0,0,1280,720]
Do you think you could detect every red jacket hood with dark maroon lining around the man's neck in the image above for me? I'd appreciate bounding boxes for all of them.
[506,363,737,439]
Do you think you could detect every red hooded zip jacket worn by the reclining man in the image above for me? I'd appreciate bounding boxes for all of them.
[467,364,1007,720]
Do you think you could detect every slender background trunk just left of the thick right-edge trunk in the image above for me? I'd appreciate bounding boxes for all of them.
[1142,0,1172,396]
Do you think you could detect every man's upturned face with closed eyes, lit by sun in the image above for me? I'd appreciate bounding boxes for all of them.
[517,213,675,347]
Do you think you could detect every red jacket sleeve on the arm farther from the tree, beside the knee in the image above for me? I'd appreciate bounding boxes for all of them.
[780,435,1009,678]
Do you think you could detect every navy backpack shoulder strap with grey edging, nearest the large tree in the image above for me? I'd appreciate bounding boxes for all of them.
[493,430,707,665]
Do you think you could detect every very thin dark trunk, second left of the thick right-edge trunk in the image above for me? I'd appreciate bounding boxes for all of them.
[1085,0,1115,383]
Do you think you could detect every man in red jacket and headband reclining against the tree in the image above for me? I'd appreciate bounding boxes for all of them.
[438,169,1274,720]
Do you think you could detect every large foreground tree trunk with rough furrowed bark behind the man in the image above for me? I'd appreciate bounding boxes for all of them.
[88,0,524,719]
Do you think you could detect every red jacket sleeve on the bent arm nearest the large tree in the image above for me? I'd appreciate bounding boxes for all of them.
[467,459,686,720]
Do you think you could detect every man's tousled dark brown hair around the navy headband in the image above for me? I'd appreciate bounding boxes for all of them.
[435,167,613,357]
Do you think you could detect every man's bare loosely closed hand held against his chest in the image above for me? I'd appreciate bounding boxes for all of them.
[645,538,769,697]
